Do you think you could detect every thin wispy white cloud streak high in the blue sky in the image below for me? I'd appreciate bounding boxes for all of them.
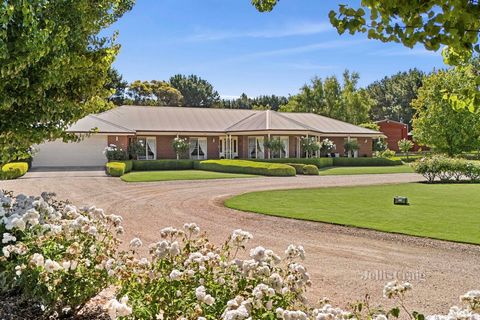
[185,22,333,42]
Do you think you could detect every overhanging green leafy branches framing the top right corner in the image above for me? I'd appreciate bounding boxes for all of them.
[251,0,480,111]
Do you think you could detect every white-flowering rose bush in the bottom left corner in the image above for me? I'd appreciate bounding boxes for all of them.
[0,192,123,312]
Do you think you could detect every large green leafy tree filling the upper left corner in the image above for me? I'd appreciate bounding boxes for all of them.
[0,0,133,164]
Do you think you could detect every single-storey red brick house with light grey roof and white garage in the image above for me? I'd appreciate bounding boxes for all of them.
[33,106,384,167]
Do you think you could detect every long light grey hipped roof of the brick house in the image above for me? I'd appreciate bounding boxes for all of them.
[69,106,382,136]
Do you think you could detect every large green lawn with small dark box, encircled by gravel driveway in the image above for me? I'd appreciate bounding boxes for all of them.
[225,183,480,244]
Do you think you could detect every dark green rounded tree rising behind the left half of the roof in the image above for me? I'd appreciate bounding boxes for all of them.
[169,74,220,108]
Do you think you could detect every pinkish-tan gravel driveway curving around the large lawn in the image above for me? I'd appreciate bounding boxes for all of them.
[0,170,480,312]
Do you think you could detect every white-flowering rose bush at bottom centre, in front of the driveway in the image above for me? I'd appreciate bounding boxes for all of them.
[116,224,310,319]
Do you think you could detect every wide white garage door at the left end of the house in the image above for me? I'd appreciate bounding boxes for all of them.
[32,135,108,167]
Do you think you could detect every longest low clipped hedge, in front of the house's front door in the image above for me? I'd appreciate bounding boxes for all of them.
[196,160,295,177]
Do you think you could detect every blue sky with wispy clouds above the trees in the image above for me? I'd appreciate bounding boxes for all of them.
[113,0,444,97]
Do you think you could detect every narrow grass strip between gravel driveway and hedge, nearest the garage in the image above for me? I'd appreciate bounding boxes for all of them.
[121,170,256,182]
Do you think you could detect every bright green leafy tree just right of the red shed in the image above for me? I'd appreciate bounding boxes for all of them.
[412,62,480,155]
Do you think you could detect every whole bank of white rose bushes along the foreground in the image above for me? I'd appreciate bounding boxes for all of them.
[0,192,480,320]
